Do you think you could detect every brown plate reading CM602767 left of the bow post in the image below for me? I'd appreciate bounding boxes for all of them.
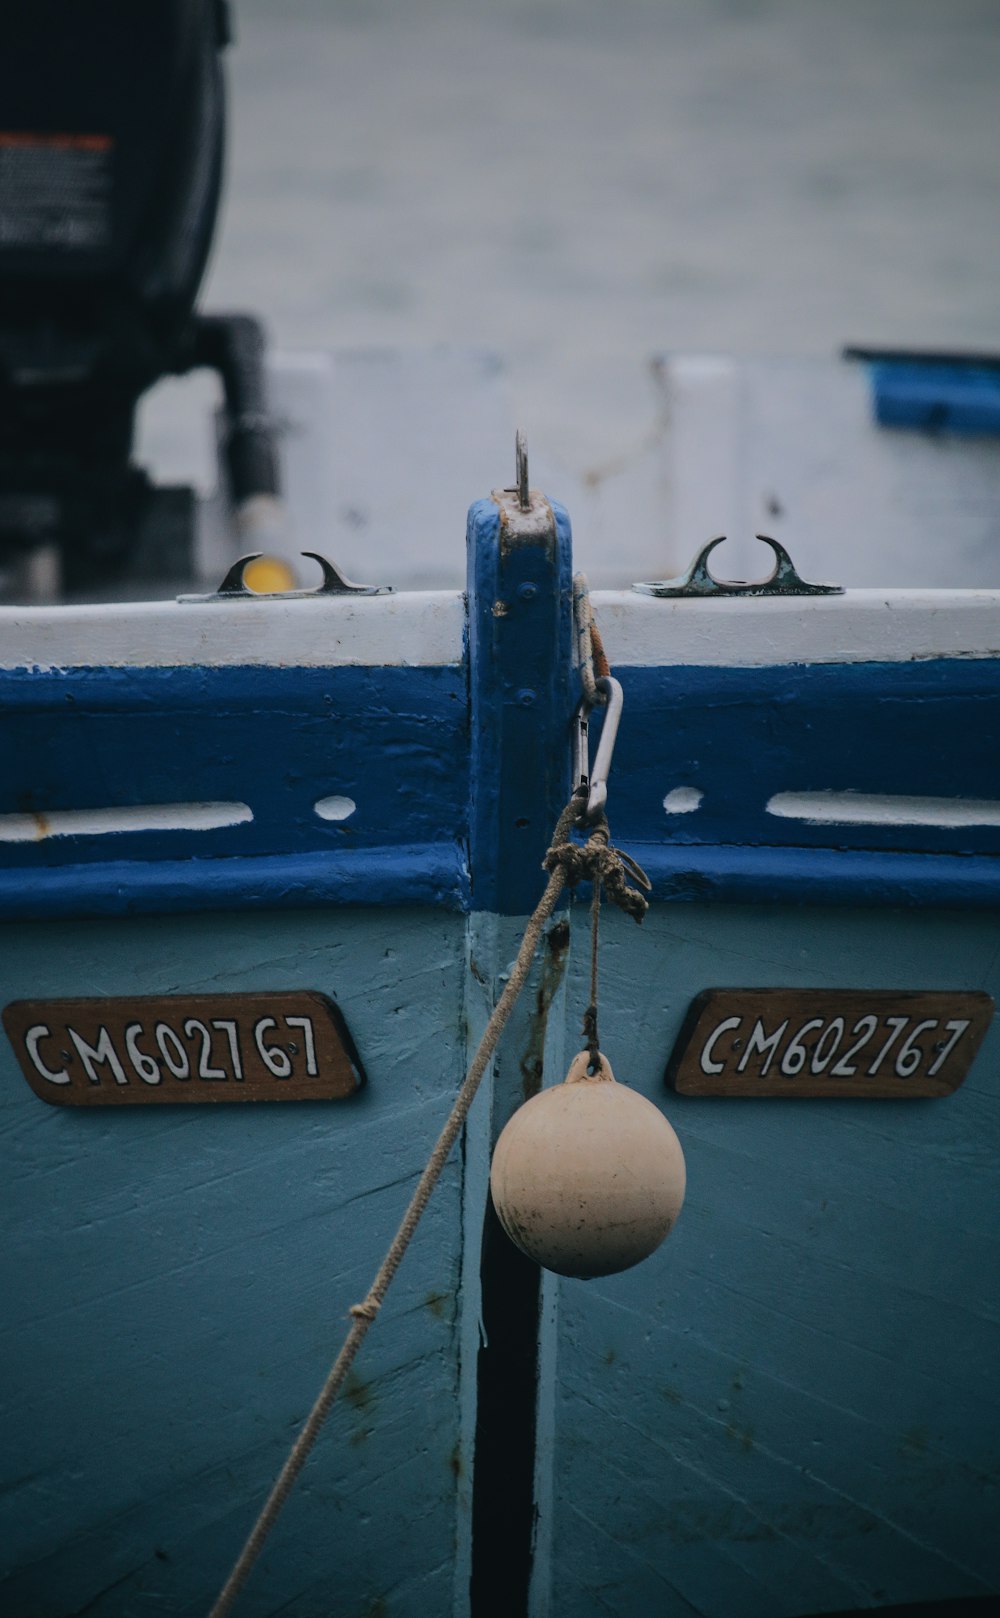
[3,990,364,1107]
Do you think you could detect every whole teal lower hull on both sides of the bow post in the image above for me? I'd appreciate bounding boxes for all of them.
[2,906,1000,1618]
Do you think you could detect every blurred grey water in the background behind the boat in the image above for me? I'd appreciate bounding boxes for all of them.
[204,0,1000,456]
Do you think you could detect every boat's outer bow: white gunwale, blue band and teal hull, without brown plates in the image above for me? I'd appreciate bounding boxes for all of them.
[0,407,1000,1618]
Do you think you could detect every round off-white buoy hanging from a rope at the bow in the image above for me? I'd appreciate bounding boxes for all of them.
[490,1050,686,1277]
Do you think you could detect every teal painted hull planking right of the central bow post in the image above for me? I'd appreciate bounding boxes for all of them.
[552,906,1000,1618]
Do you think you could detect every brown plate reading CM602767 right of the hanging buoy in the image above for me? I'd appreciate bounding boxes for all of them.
[667,989,994,1097]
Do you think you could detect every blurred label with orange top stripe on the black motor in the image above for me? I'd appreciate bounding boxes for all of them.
[0,129,113,252]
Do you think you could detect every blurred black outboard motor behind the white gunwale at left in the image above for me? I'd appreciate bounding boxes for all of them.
[0,0,277,592]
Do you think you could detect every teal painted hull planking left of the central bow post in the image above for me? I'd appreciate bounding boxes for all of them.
[0,911,464,1618]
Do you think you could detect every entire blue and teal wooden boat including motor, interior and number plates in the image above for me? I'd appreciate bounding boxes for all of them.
[0,0,1000,1618]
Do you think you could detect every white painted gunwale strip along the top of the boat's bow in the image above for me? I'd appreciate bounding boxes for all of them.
[0,591,1000,670]
